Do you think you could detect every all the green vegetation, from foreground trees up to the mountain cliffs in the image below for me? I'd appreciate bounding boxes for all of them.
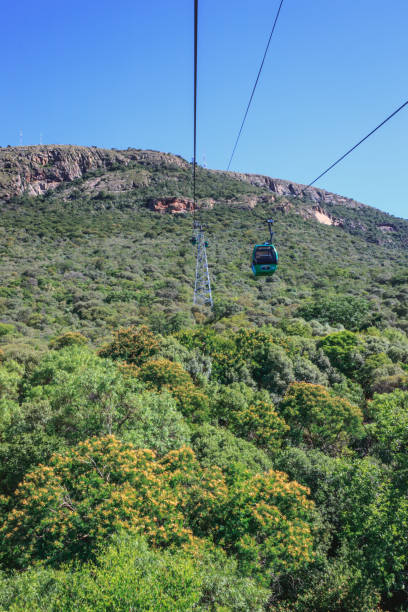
[0,149,408,612]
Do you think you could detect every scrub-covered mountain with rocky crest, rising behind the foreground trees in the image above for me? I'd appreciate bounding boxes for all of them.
[0,145,408,339]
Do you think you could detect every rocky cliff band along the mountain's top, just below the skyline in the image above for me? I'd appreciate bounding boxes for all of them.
[0,145,408,248]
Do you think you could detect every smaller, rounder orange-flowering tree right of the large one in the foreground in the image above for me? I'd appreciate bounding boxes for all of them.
[212,470,314,583]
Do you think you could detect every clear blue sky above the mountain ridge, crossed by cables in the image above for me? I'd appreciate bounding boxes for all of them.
[0,0,408,218]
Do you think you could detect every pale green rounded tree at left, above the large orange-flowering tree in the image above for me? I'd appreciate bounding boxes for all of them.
[25,346,143,443]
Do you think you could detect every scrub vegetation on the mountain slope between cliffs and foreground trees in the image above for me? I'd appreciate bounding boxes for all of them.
[0,151,408,345]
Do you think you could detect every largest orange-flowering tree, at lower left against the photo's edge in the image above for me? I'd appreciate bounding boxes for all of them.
[0,436,198,567]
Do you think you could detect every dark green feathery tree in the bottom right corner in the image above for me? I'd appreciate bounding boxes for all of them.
[277,448,408,609]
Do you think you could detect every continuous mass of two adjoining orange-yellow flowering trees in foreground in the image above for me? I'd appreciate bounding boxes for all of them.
[0,436,313,574]
